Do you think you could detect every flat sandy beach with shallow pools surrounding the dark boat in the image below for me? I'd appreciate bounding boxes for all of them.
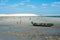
[0,17,60,40]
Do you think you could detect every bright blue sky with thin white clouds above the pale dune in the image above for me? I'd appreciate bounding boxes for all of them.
[0,0,60,14]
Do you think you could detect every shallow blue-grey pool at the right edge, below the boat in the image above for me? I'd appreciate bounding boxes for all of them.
[39,28,60,35]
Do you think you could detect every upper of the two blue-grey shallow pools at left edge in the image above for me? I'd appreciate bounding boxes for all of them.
[0,26,30,32]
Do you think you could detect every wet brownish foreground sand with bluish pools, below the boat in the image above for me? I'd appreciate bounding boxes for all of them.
[0,25,60,40]
